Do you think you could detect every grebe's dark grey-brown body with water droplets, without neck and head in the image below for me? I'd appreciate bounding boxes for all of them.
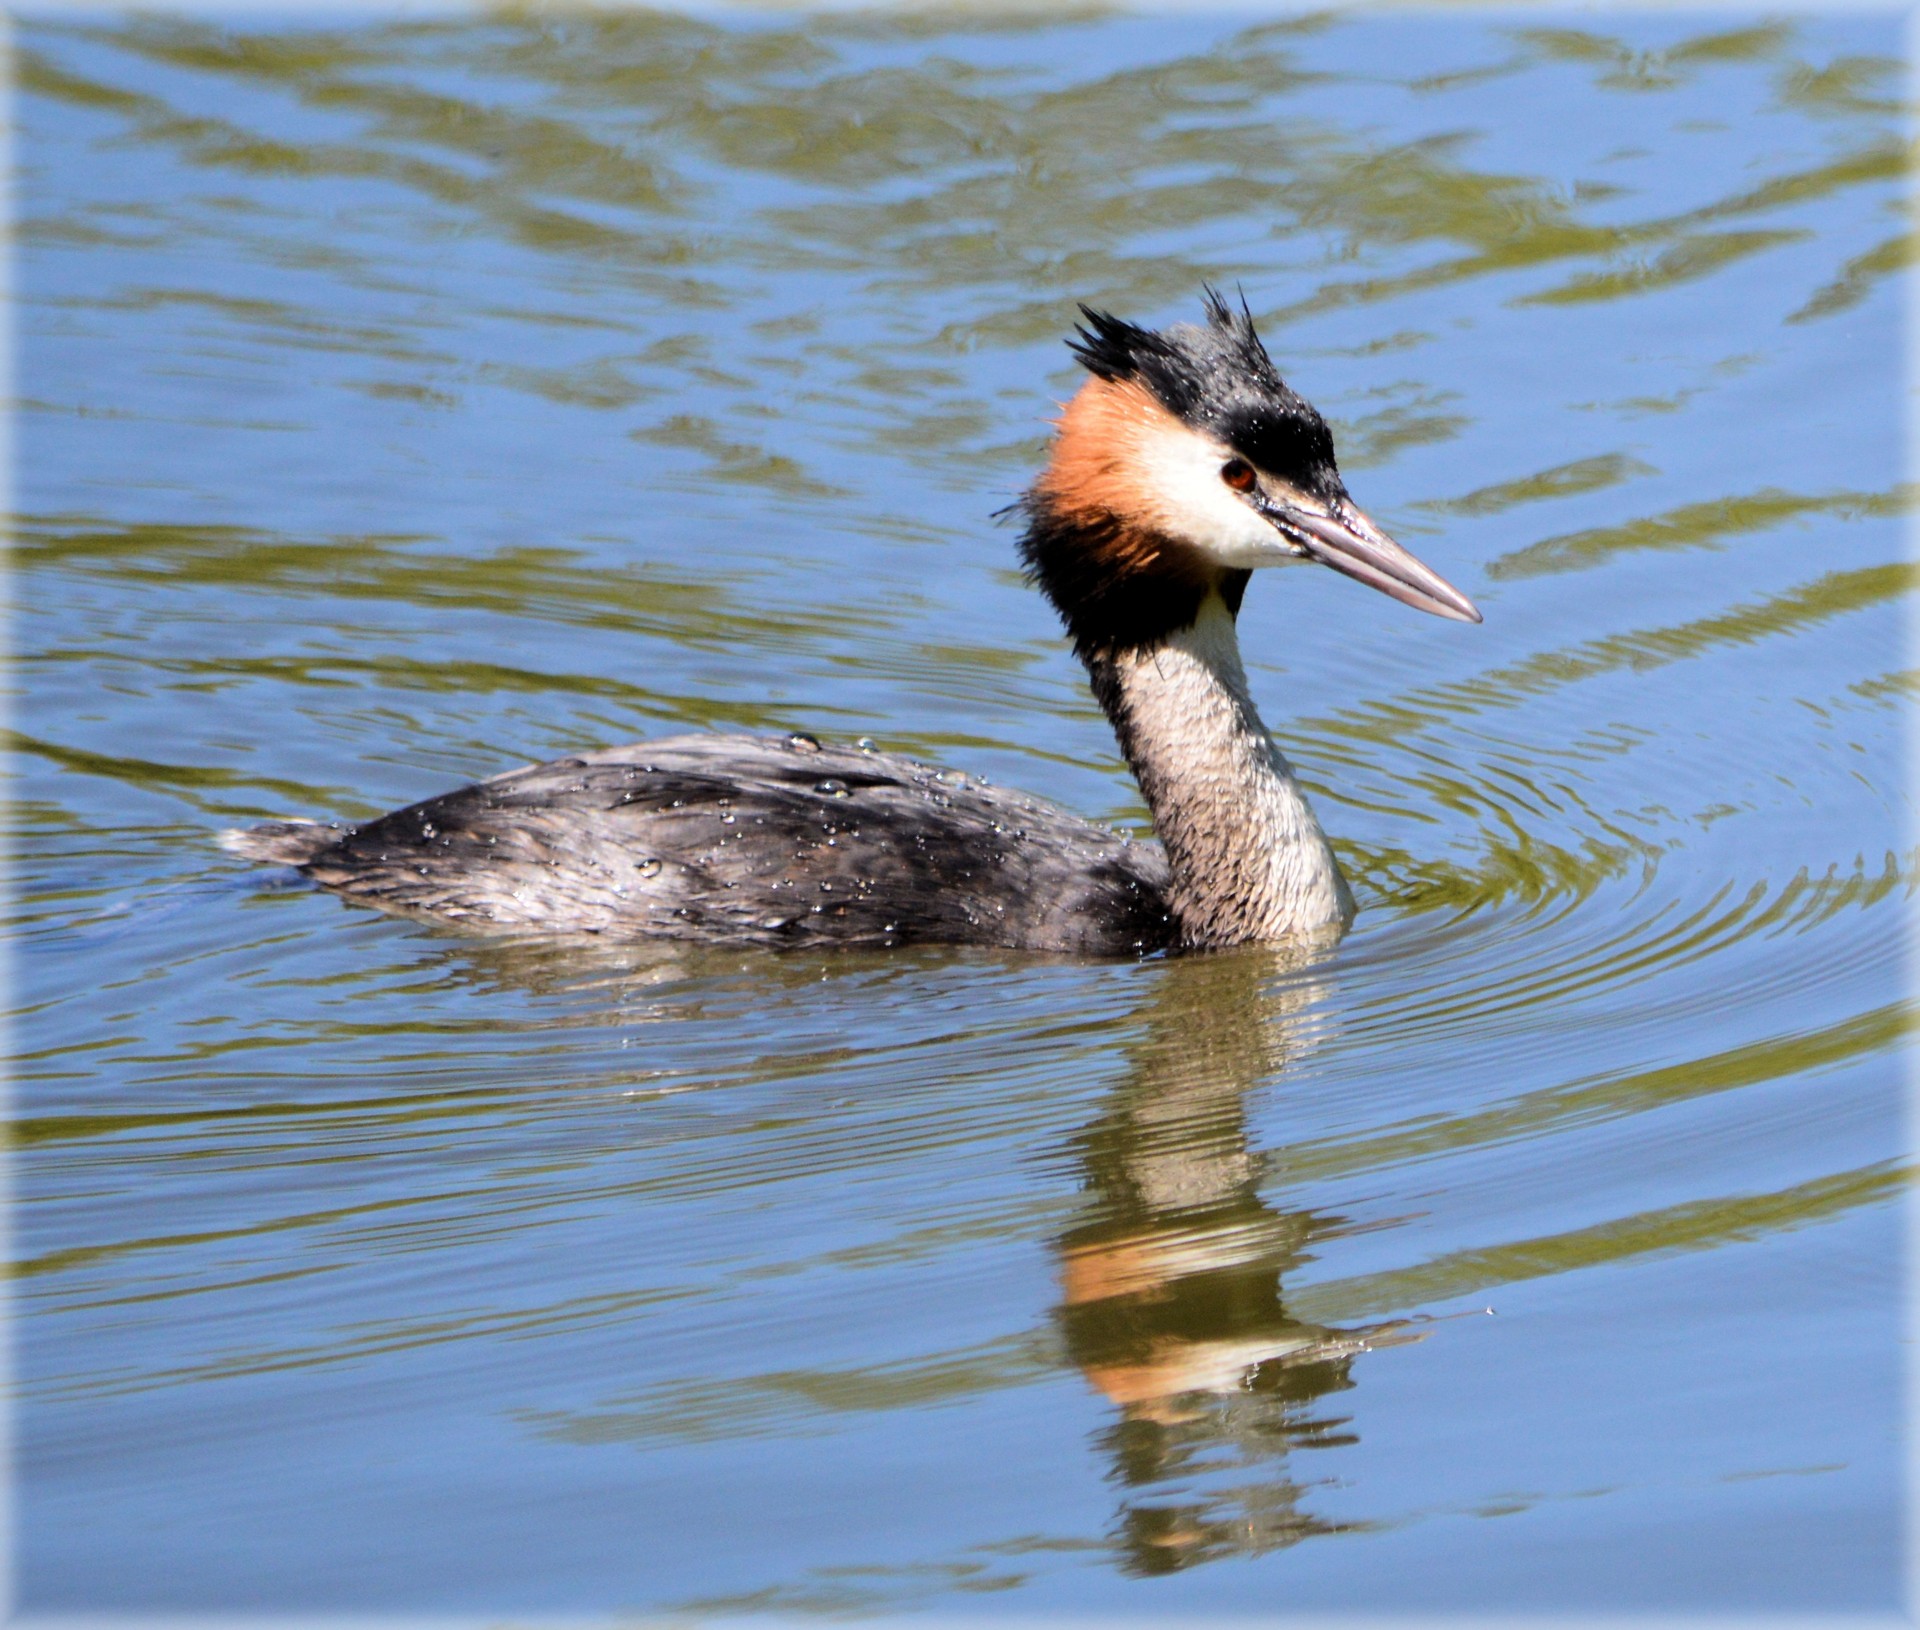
[228,735,1175,954]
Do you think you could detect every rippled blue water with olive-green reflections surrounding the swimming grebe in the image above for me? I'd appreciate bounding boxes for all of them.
[12,12,1914,1615]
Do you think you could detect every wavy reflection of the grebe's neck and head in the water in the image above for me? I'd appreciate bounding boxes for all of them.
[1058,950,1417,1574]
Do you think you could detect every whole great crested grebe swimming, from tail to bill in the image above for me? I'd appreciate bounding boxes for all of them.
[223,290,1480,954]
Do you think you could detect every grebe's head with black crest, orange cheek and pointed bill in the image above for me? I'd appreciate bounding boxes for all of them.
[1021,288,1480,651]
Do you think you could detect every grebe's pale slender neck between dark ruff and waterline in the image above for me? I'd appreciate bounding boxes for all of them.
[1085,593,1354,945]
